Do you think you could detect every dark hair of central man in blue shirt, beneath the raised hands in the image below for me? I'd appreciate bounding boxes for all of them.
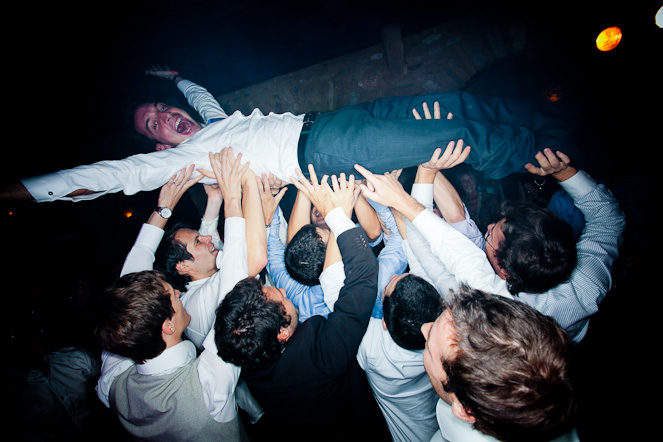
[285,224,327,286]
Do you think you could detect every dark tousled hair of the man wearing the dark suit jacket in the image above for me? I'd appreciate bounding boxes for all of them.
[214,277,292,369]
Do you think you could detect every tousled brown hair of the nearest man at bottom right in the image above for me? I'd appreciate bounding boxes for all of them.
[443,287,576,442]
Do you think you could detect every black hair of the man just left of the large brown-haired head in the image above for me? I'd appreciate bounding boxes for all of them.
[383,275,444,350]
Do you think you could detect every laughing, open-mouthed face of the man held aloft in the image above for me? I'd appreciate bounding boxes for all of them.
[134,103,201,150]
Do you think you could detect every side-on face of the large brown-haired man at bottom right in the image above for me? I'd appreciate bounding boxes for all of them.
[421,310,458,404]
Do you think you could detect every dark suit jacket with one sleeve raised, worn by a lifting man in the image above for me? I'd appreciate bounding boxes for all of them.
[242,227,378,440]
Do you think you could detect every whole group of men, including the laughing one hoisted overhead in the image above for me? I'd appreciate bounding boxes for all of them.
[6,70,625,441]
